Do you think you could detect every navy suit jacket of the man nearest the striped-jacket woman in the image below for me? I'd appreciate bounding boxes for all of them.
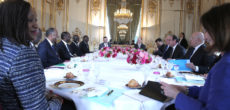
[38,39,62,68]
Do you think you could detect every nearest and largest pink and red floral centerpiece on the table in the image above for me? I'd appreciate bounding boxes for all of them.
[127,49,152,64]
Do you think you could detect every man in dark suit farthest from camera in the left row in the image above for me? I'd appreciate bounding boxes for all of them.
[80,35,90,56]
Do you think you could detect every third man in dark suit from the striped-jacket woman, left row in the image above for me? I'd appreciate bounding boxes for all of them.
[70,35,81,56]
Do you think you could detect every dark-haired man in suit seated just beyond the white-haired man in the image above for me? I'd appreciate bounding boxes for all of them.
[163,35,185,59]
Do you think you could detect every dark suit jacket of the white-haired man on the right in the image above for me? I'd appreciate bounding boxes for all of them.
[184,45,215,74]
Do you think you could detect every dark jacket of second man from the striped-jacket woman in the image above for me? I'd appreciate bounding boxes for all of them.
[57,41,72,62]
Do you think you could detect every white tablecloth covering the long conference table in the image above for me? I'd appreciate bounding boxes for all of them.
[45,58,203,110]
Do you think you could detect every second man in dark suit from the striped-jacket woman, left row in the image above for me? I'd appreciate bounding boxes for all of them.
[57,32,73,62]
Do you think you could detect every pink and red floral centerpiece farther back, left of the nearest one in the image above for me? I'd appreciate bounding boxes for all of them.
[99,47,117,58]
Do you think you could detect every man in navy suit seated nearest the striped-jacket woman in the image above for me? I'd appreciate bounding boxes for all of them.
[38,28,62,68]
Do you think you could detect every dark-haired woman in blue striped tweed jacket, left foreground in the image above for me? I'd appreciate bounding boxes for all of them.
[0,0,62,110]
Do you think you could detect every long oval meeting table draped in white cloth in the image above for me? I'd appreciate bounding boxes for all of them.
[44,56,203,110]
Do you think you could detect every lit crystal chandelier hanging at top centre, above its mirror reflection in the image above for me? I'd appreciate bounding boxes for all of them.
[114,0,133,24]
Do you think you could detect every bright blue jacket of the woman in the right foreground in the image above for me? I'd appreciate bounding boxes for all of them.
[175,52,230,110]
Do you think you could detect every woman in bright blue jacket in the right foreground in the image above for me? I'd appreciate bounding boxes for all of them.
[161,3,230,110]
